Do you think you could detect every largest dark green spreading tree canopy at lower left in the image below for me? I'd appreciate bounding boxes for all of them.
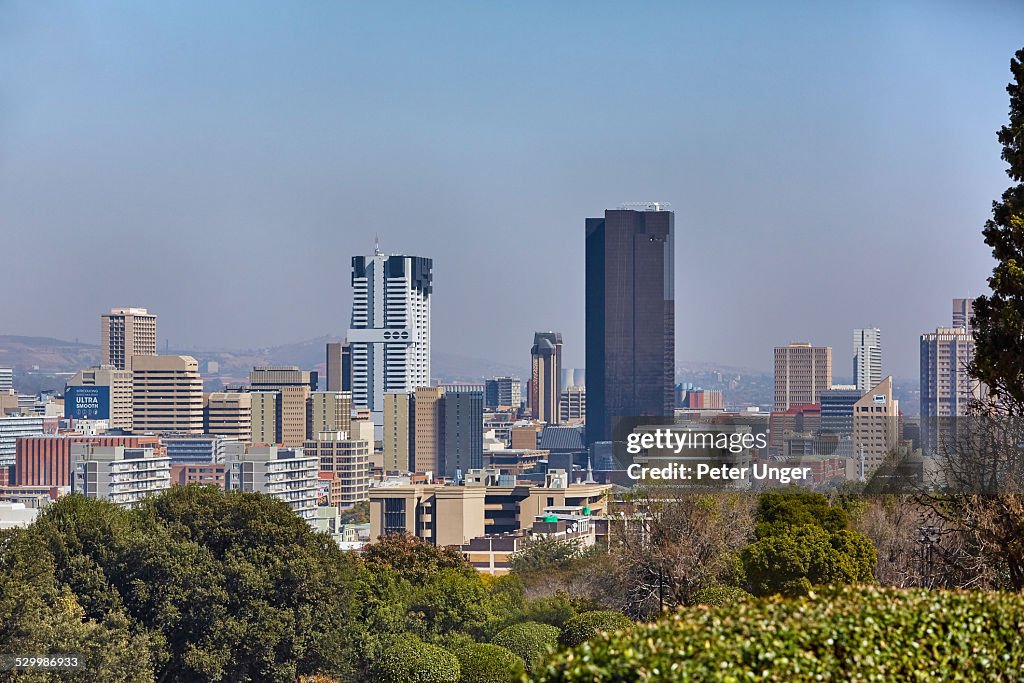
[24,486,357,681]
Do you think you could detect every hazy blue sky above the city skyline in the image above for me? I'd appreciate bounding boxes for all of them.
[0,0,1024,377]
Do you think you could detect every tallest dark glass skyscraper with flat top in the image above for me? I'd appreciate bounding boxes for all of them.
[587,204,676,443]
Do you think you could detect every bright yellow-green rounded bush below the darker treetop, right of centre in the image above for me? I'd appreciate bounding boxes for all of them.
[742,524,877,595]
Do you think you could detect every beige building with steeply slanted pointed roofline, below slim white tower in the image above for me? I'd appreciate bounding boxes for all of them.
[848,376,900,479]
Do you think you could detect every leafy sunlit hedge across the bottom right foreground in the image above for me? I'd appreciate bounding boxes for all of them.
[534,586,1024,683]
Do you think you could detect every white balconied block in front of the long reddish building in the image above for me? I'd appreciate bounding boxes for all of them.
[71,442,171,507]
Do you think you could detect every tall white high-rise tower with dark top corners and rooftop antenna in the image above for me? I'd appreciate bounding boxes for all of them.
[348,248,433,426]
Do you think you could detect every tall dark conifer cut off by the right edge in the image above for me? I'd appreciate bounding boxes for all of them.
[972,49,1024,405]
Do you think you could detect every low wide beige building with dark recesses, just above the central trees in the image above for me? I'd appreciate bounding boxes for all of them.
[370,470,611,546]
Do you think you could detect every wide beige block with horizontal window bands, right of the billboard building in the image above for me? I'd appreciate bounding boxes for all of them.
[132,355,203,434]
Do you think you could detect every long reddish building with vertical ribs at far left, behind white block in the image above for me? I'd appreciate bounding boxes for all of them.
[13,434,166,486]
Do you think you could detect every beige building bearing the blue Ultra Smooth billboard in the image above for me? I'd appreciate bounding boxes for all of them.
[65,366,132,431]
